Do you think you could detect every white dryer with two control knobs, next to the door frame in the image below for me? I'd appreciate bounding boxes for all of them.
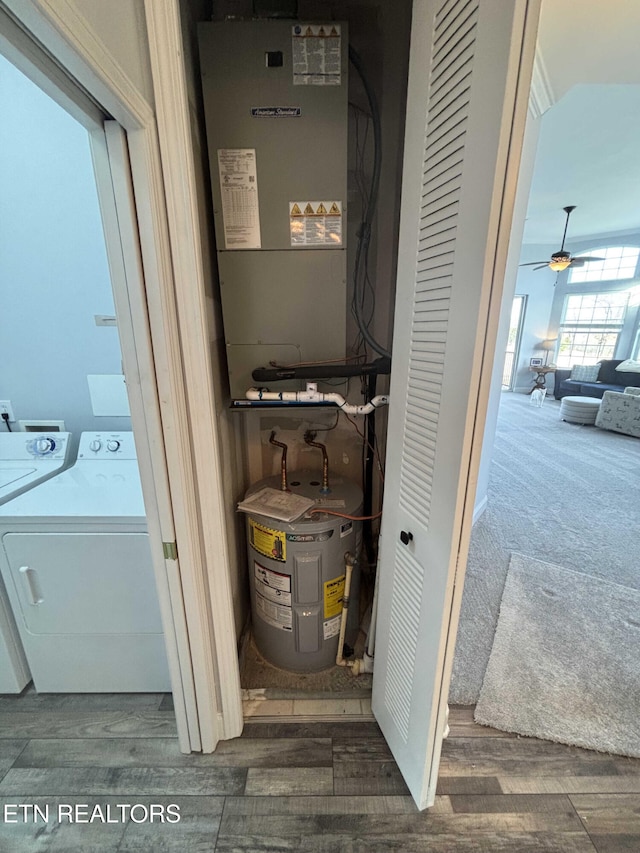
[0,432,171,693]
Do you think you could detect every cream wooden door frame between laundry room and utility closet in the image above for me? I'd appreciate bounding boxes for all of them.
[3,0,242,752]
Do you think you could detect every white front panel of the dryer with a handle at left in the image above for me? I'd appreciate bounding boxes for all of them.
[0,532,170,693]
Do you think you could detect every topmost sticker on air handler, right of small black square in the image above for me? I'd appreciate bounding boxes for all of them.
[291,24,341,86]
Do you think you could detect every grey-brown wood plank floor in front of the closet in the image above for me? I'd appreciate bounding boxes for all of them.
[0,694,640,853]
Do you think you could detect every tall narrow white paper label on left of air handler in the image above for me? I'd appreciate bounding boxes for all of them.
[218,148,261,249]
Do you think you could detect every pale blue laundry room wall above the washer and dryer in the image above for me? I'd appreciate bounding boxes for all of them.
[0,57,131,438]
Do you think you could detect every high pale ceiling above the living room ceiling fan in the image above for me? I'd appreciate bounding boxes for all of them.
[523,0,640,249]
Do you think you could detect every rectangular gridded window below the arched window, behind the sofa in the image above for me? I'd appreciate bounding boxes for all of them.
[556,291,629,367]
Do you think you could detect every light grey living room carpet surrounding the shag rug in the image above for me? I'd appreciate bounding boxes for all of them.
[449,392,640,705]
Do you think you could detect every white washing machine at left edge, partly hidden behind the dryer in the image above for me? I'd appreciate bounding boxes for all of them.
[0,432,71,693]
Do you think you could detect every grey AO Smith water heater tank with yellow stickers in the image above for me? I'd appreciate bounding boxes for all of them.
[247,471,362,672]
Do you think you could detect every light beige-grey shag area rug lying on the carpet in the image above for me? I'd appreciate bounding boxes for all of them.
[475,554,640,757]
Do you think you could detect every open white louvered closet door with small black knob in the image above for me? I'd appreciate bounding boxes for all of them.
[373,0,539,808]
